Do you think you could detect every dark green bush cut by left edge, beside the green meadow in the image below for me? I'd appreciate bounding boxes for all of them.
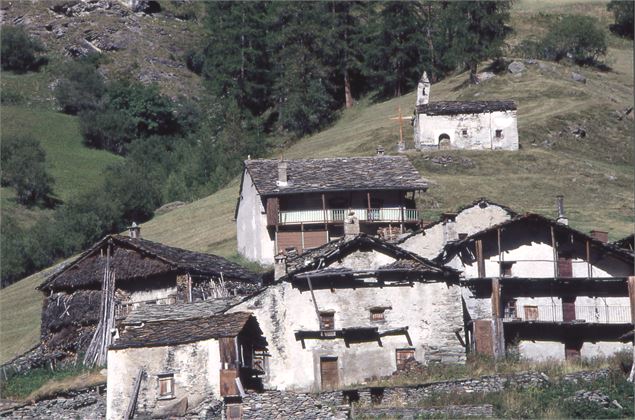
[1,136,54,205]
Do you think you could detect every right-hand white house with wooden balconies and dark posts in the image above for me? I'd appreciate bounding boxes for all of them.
[436,214,635,359]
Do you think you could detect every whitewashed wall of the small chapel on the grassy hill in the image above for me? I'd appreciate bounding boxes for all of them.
[414,110,518,150]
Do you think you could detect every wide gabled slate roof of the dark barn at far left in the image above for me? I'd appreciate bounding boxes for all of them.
[38,235,258,290]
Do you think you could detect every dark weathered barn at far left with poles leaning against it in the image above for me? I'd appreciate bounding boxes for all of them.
[38,226,260,359]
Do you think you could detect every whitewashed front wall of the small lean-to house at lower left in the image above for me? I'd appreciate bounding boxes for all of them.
[106,339,221,420]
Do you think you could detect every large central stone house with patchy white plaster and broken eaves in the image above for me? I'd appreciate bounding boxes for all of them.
[230,235,465,392]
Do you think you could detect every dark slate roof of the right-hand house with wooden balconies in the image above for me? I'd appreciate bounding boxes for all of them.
[434,213,634,264]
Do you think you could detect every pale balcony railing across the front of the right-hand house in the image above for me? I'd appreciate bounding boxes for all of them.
[504,305,631,324]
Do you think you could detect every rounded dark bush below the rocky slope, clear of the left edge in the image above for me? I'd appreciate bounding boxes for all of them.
[55,60,106,115]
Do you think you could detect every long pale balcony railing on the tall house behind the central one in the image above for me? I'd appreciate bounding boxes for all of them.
[278,207,419,225]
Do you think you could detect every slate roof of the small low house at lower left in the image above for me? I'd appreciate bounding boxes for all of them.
[110,305,262,349]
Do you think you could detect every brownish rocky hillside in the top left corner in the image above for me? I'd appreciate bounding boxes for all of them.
[0,0,203,97]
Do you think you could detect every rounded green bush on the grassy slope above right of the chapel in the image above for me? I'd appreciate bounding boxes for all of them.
[543,16,607,64]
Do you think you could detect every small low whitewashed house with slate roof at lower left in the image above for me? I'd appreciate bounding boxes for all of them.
[107,310,267,419]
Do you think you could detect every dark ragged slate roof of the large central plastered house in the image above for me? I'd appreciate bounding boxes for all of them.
[286,234,458,278]
